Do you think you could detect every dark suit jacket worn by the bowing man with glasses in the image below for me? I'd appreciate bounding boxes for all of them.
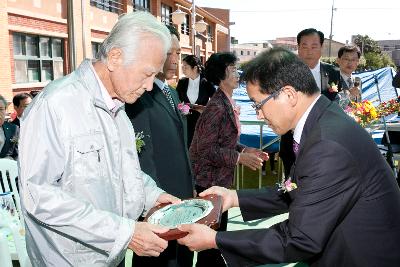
[217,96,400,267]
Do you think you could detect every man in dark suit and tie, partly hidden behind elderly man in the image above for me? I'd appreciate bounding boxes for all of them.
[125,27,194,267]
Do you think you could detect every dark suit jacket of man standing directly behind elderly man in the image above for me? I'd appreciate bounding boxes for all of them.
[125,84,194,198]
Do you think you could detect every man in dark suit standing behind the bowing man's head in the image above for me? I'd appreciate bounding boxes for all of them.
[279,28,341,176]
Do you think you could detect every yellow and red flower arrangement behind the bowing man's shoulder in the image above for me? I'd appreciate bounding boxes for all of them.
[344,100,379,127]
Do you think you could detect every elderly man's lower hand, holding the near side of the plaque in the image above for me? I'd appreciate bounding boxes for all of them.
[128,222,168,257]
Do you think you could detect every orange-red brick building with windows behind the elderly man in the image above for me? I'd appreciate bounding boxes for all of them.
[0,0,230,107]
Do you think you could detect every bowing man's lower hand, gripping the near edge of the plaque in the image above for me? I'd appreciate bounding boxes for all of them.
[178,223,217,252]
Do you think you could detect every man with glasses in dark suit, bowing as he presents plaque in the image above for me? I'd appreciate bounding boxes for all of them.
[179,48,400,267]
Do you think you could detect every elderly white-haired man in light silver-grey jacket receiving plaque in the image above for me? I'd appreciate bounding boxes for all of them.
[19,12,179,266]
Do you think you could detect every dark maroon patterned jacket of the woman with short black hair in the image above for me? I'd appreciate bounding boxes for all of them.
[190,90,244,188]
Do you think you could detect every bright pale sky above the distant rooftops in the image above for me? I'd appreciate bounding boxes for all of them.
[195,0,400,43]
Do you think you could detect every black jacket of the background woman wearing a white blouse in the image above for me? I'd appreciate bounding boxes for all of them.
[176,78,215,147]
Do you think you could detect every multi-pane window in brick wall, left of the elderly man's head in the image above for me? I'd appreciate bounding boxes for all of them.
[13,33,64,83]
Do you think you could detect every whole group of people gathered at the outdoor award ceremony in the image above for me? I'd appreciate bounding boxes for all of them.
[0,12,400,267]
